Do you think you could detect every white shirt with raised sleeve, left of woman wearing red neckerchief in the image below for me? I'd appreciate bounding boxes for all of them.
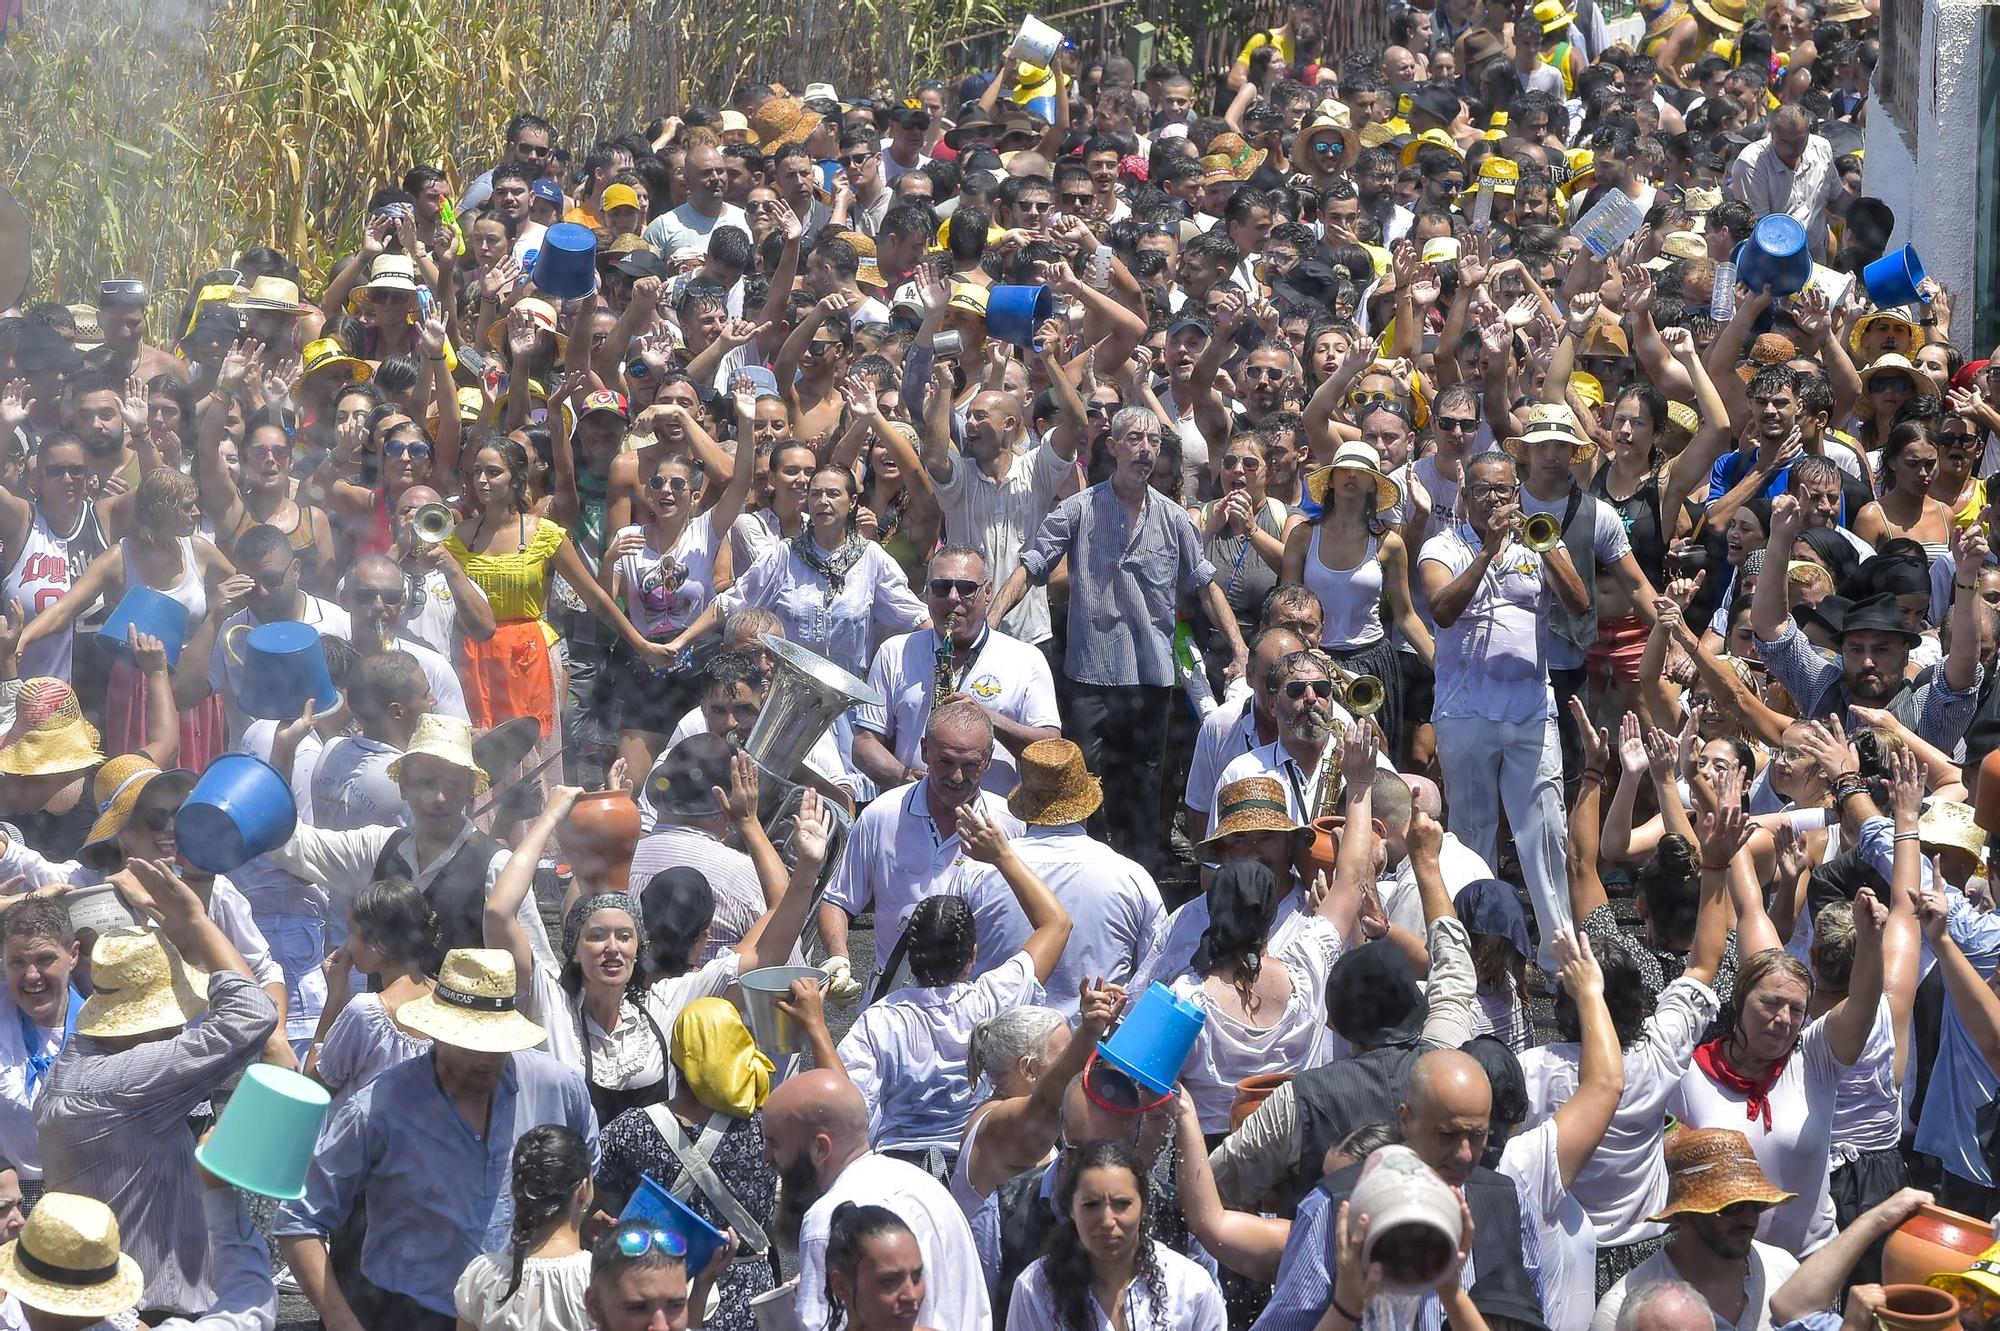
[1520,975,1748,1247]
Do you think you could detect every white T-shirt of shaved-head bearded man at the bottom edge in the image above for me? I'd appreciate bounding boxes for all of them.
[796,1151,988,1331]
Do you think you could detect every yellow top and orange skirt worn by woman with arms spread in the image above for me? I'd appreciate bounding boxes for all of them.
[444,518,568,739]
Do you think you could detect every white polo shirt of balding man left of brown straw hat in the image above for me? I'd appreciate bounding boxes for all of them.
[824,777,1024,969]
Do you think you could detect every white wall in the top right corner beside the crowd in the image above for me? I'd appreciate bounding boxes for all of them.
[1862,0,1986,350]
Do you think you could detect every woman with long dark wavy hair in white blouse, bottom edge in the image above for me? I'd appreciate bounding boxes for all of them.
[1008,1137,1228,1331]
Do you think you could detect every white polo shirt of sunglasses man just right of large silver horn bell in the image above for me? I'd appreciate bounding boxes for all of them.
[854,628,1062,795]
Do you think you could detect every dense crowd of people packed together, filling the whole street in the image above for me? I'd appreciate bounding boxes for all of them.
[0,0,2000,1331]
